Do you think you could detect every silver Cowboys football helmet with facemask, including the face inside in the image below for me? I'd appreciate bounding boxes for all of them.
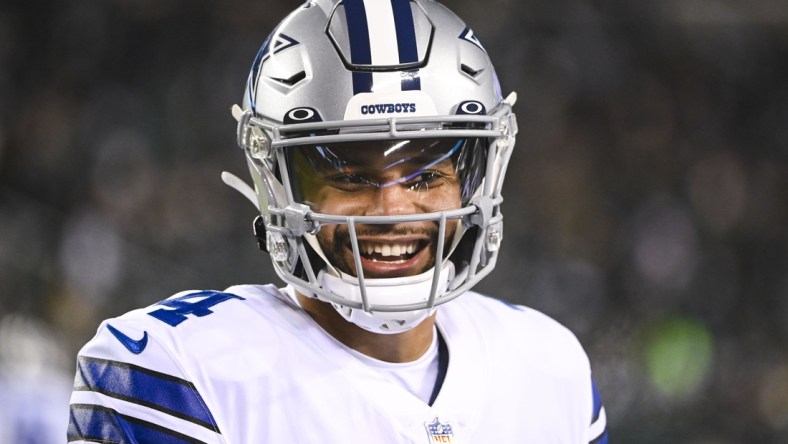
[223,0,517,333]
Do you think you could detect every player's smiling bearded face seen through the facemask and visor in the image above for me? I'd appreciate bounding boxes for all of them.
[290,139,465,278]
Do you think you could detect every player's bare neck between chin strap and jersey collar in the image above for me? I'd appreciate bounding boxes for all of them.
[296,293,435,362]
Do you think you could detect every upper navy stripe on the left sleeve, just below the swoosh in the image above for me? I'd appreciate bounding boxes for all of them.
[74,356,219,433]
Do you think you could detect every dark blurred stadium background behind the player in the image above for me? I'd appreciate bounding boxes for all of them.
[0,0,788,444]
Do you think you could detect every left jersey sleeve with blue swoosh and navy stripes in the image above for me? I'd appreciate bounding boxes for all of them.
[67,315,224,443]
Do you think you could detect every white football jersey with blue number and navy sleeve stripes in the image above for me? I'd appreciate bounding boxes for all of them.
[68,286,607,444]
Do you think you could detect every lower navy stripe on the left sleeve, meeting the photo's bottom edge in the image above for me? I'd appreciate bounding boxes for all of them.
[67,404,204,444]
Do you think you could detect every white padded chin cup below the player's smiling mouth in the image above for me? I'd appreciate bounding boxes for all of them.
[317,261,454,334]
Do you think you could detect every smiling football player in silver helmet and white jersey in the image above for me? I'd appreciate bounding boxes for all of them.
[68,0,607,444]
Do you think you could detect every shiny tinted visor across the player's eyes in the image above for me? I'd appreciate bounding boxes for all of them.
[285,138,487,216]
